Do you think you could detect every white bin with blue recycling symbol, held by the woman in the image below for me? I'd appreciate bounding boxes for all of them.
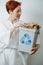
[18,27,39,53]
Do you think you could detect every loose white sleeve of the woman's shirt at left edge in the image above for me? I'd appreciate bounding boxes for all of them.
[0,23,10,48]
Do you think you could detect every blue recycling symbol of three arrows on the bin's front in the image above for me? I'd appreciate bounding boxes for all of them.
[20,33,32,45]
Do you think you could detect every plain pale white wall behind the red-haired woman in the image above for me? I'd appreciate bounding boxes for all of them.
[0,0,43,65]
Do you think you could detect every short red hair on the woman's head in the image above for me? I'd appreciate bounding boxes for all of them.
[6,0,21,13]
